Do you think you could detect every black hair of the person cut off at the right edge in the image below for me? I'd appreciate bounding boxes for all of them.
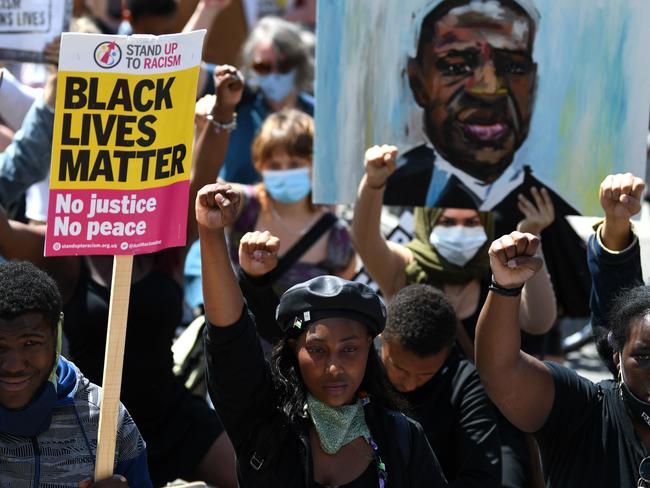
[607,286,650,352]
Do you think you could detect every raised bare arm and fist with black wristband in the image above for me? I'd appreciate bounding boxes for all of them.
[476,232,555,432]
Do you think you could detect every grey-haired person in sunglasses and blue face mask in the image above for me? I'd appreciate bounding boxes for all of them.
[201,17,314,184]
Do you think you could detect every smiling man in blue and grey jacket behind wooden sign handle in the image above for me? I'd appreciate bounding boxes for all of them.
[0,261,151,488]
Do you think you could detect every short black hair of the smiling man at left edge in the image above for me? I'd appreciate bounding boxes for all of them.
[0,261,63,327]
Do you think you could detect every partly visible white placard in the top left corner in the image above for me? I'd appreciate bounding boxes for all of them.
[0,0,72,62]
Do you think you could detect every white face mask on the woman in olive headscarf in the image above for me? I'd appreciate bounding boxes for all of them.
[429,225,487,268]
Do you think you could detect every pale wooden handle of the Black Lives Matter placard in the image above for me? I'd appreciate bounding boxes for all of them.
[95,256,133,480]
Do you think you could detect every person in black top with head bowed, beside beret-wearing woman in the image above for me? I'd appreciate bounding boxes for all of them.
[375,285,502,487]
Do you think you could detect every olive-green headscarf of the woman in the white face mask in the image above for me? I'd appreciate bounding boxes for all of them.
[405,208,494,287]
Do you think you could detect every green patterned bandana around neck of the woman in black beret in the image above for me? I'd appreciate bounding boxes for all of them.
[307,393,370,455]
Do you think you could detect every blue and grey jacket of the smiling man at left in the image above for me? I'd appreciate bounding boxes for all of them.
[0,357,152,488]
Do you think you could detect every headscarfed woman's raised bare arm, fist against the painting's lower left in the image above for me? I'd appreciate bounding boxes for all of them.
[352,145,413,299]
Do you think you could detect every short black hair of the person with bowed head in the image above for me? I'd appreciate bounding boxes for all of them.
[383,284,458,357]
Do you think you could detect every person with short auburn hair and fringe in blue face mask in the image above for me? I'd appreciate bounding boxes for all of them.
[186,110,356,306]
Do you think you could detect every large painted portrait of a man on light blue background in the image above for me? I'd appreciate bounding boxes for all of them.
[314,0,650,215]
